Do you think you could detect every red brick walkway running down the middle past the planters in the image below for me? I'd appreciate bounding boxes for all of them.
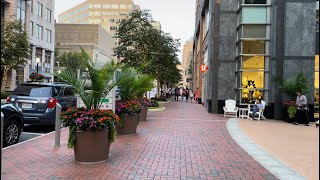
[1,102,276,180]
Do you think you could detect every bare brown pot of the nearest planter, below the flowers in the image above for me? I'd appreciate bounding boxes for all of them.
[74,128,110,164]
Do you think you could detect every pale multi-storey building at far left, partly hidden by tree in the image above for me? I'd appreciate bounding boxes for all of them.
[1,0,55,91]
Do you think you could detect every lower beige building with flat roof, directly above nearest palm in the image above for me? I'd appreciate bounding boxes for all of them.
[55,24,115,66]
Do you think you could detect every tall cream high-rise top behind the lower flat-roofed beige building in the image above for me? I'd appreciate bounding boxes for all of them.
[59,0,139,44]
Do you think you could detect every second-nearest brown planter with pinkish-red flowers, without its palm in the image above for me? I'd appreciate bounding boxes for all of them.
[116,100,142,135]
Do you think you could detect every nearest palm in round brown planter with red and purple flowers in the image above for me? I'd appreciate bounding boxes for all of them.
[57,49,120,162]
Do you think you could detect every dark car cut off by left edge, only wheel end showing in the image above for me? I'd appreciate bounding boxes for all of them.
[1,102,24,147]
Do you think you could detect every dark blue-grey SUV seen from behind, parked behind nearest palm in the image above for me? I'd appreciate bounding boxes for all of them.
[7,82,77,125]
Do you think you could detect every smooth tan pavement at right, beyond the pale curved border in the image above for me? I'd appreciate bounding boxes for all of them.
[239,119,319,180]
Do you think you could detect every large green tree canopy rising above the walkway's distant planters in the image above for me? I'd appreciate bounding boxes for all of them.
[115,10,181,84]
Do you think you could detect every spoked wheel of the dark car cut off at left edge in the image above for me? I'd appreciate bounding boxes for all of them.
[3,119,21,147]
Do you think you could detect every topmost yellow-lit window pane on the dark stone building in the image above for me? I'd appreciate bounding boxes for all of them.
[242,41,266,54]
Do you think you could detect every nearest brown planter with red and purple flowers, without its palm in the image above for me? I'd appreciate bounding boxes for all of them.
[61,108,120,163]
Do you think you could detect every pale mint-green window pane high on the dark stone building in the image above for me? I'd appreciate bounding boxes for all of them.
[241,7,267,23]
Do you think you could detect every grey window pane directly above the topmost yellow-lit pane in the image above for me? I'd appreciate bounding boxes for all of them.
[243,25,267,38]
